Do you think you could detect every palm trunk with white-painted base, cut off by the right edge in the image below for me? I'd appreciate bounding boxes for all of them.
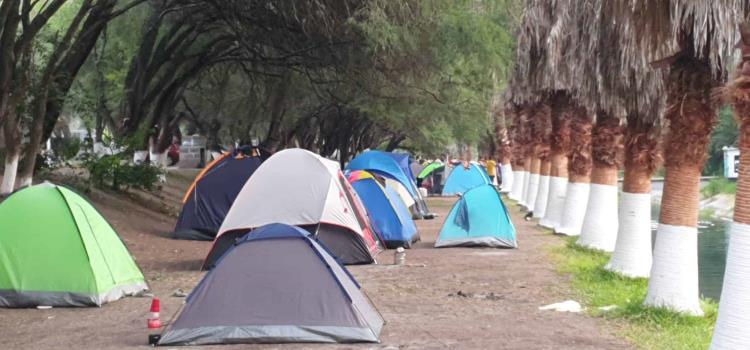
[711,28,750,350]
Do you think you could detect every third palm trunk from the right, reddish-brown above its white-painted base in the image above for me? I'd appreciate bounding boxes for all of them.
[604,126,660,278]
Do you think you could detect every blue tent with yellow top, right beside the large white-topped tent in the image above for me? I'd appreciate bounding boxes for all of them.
[349,171,419,249]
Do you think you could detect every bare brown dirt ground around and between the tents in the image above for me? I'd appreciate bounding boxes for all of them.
[0,174,630,350]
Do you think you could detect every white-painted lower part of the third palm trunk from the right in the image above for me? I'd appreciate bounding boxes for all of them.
[604,192,652,278]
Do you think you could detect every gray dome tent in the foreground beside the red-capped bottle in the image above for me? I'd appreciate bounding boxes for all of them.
[159,224,384,345]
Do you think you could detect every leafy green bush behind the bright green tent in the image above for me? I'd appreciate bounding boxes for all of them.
[83,154,163,191]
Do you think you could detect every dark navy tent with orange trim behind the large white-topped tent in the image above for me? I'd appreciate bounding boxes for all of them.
[172,153,262,241]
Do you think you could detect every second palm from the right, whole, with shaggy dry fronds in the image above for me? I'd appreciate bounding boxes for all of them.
[625,0,747,315]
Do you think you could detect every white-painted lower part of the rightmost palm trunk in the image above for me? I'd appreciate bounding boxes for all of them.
[711,222,750,350]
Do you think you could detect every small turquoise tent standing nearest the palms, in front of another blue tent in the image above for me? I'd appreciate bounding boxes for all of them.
[435,185,517,248]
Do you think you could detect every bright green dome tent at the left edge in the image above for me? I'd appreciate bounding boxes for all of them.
[0,183,148,307]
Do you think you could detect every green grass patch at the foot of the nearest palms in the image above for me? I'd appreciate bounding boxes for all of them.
[551,237,718,350]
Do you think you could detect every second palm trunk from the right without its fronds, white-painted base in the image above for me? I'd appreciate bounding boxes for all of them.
[645,54,718,315]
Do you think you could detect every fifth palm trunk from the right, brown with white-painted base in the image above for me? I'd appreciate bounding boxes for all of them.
[555,107,591,236]
